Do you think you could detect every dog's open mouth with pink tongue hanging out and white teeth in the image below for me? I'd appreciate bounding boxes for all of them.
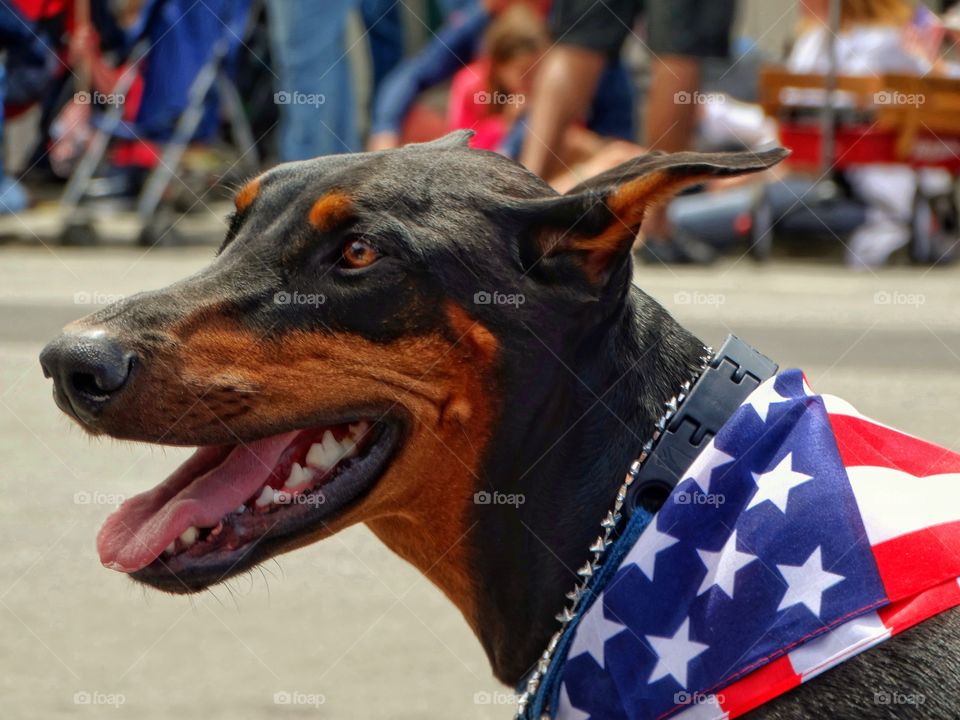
[97,419,399,592]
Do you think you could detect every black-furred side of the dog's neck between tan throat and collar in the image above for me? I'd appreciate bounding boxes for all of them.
[470,287,704,683]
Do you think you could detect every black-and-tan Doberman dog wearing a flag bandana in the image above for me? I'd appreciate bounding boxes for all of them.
[41,133,960,718]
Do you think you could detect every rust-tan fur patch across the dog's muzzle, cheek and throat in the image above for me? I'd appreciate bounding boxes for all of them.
[107,304,499,629]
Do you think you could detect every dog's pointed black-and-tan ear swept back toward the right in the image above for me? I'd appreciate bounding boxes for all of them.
[520,148,789,286]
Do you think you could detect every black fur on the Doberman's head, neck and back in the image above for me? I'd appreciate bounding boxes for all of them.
[37,134,960,720]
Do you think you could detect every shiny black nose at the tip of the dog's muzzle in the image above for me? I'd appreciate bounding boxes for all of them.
[40,330,136,421]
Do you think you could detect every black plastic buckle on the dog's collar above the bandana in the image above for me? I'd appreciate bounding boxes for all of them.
[623,335,778,517]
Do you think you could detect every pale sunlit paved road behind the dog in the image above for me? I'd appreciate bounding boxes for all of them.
[0,246,960,720]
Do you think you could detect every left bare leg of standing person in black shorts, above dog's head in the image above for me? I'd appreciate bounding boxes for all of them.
[520,45,607,177]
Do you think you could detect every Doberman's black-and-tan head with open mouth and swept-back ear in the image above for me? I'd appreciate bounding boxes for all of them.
[41,134,783,595]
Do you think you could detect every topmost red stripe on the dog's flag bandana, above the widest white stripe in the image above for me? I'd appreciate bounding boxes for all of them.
[830,414,960,477]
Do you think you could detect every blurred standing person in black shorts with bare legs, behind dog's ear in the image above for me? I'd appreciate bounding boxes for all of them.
[520,0,735,262]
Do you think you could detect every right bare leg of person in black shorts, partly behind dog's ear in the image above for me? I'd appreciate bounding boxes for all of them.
[643,55,700,237]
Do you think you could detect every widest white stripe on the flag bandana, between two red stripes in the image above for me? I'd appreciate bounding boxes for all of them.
[847,465,960,545]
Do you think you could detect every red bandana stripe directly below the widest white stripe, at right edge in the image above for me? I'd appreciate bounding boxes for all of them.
[872,521,960,601]
